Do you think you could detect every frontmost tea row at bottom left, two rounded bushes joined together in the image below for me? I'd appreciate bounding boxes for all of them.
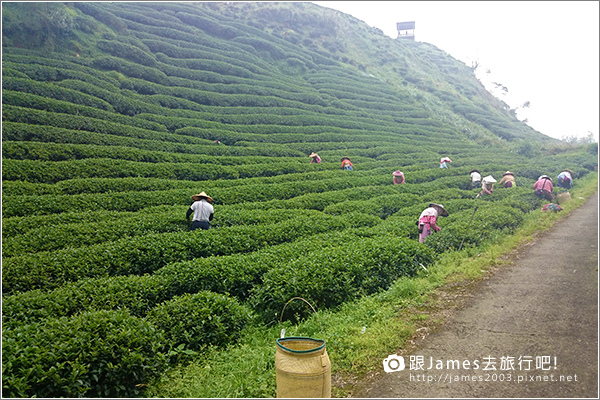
[2,291,251,398]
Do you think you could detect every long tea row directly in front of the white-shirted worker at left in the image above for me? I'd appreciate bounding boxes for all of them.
[2,214,366,294]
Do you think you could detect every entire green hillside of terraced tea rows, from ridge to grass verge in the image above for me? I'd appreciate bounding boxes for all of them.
[2,2,597,397]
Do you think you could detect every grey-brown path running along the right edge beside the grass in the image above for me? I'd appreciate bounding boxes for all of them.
[352,193,598,398]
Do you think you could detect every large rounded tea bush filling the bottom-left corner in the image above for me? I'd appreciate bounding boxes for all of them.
[2,311,167,398]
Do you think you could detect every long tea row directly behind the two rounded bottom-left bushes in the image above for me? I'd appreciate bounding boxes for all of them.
[2,230,368,327]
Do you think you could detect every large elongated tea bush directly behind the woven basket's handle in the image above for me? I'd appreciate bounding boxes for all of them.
[249,237,433,322]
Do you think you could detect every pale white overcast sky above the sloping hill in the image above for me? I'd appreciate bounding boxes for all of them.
[313,1,600,141]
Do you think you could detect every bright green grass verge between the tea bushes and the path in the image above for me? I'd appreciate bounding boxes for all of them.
[145,172,598,398]
